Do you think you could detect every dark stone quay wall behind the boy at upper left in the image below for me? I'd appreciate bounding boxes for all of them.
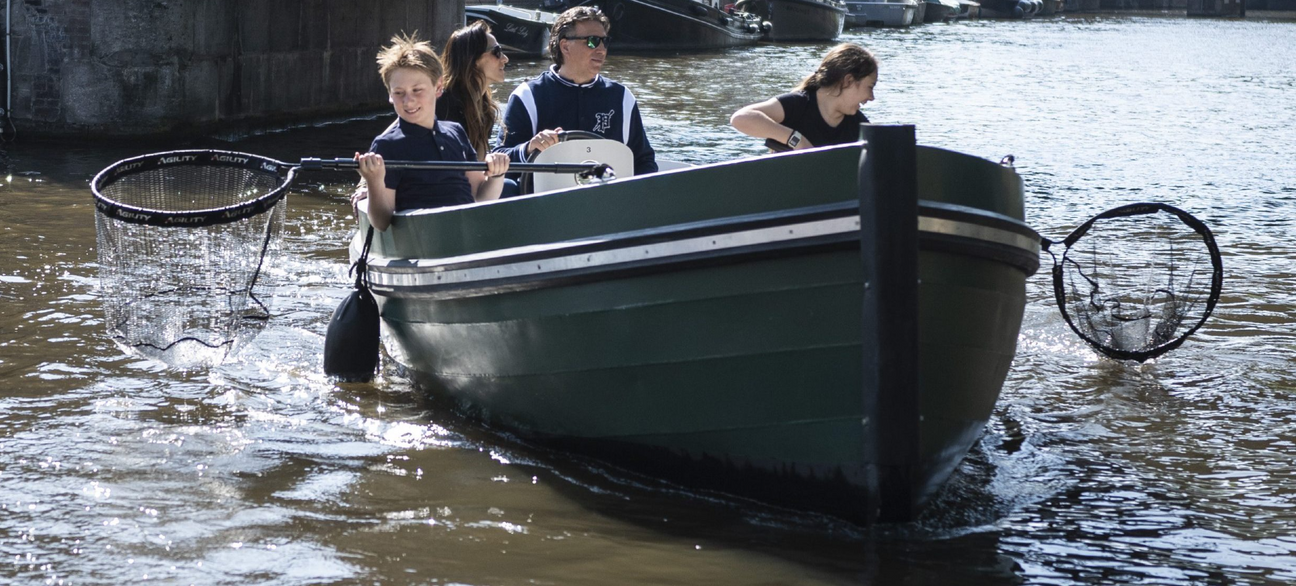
[10,0,464,136]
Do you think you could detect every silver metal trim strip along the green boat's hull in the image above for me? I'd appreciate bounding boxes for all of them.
[369,204,1039,298]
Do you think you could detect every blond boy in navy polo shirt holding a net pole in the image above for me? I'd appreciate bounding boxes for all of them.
[355,35,508,231]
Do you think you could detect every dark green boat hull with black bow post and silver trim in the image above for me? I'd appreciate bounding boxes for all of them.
[351,126,1039,524]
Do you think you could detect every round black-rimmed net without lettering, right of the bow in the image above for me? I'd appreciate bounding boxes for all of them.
[1054,204,1223,362]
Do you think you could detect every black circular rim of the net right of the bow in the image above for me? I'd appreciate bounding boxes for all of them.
[1045,202,1223,362]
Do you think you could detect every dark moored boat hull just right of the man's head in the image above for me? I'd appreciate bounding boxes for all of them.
[594,0,763,51]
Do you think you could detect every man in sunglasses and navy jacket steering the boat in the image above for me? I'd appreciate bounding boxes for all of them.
[495,6,657,175]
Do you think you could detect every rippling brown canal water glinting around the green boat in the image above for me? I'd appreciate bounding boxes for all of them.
[0,17,1296,585]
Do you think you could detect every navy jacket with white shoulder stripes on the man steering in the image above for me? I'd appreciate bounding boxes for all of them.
[495,65,657,175]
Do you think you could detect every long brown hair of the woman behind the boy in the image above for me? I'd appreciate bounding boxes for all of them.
[441,21,499,154]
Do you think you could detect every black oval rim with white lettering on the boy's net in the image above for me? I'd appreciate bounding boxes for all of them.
[91,149,298,228]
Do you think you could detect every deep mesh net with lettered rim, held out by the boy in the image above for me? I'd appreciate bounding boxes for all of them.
[92,150,294,368]
